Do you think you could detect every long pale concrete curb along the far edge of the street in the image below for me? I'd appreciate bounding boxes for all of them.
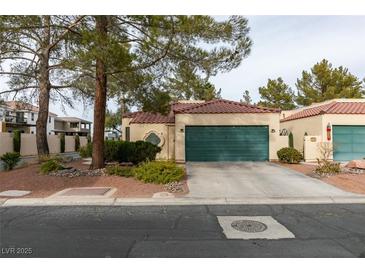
[0,196,365,207]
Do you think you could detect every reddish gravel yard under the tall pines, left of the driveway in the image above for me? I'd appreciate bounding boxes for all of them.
[0,160,188,198]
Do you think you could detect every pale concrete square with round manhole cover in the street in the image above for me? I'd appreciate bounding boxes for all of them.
[217,216,295,240]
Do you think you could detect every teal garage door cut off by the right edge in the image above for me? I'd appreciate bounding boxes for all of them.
[333,126,365,161]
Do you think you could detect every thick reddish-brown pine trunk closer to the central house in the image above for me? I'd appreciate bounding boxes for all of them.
[92,16,108,169]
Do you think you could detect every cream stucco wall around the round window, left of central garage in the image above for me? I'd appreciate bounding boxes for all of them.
[122,118,175,160]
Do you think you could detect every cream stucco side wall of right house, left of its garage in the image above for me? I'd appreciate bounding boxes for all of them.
[280,115,322,152]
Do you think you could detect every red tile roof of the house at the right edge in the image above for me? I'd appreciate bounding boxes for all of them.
[281,102,365,122]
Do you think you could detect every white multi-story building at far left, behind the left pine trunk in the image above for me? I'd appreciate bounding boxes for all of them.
[0,101,57,134]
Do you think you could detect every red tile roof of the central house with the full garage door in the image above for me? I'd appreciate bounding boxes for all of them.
[123,99,280,124]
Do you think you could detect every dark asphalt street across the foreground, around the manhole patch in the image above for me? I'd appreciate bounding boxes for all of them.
[0,204,365,258]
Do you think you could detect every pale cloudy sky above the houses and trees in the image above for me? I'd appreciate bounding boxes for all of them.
[2,16,365,120]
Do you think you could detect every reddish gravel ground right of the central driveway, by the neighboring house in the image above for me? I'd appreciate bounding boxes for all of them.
[277,163,365,194]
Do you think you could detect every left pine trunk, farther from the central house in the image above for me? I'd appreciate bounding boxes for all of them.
[36,15,51,156]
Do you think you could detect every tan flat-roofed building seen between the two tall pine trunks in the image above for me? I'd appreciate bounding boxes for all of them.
[53,117,92,136]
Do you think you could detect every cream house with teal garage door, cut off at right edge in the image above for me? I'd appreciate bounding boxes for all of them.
[280,99,365,161]
